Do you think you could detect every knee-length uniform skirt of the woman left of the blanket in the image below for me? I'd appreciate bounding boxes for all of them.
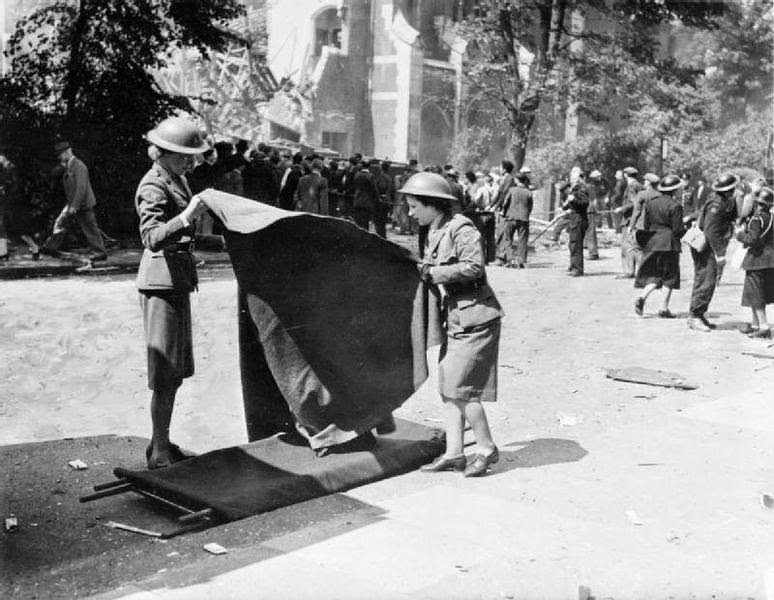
[140,292,194,390]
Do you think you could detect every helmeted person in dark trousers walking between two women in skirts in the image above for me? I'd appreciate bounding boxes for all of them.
[688,173,739,331]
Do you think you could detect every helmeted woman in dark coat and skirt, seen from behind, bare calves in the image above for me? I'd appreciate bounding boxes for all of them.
[634,174,683,319]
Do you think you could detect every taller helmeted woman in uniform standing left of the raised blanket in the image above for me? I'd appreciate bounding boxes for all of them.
[135,117,223,469]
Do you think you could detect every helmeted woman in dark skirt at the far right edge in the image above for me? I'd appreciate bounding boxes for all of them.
[736,188,774,339]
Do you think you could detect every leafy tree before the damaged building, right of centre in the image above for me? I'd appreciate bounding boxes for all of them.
[458,0,723,165]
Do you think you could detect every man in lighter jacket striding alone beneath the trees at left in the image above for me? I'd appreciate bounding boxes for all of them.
[40,140,107,262]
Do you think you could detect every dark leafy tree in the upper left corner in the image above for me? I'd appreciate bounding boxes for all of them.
[0,0,244,232]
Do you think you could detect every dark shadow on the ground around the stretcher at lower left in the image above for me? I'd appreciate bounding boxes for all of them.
[0,435,383,599]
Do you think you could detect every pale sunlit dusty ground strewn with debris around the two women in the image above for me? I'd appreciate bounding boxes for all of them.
[0,239,774,600]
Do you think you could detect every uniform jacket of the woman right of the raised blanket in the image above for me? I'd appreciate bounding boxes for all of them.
[425,215,504,335]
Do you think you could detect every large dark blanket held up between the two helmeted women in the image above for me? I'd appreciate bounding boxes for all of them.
[200,190,439,446]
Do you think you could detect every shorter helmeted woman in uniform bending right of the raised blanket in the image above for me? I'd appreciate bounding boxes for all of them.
[399,173,503,477]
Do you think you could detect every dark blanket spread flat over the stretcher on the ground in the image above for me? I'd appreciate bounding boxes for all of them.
[114,419,444,521]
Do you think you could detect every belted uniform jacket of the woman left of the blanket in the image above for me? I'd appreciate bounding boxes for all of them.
[135,163,197,293]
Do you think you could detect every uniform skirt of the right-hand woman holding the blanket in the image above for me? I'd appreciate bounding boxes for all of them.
[438,319,500,402]
